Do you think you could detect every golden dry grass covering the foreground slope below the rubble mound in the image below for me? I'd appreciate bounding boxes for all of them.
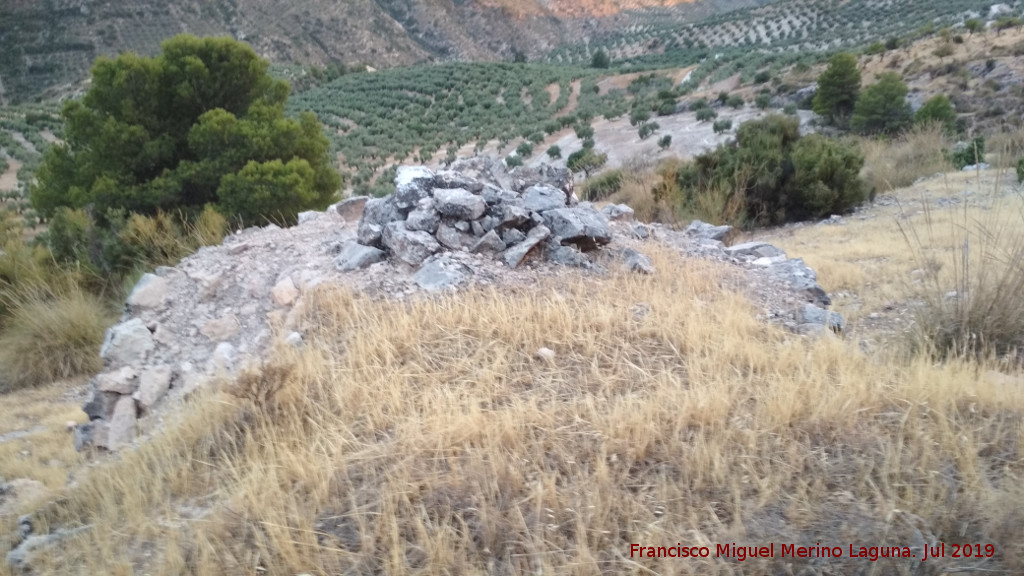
[8,242,1024,575]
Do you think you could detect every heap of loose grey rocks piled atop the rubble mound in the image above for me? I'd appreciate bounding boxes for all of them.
[337,159,650,280]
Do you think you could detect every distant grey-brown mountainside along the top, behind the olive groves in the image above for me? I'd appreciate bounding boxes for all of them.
[0,0,756,105]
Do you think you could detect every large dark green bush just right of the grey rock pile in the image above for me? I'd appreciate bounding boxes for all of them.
[656,115,867,225]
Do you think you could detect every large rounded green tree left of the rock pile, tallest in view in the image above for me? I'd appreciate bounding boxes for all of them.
[31,35,341,222]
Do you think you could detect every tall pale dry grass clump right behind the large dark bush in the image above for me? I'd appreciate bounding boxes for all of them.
[860,124,952,194]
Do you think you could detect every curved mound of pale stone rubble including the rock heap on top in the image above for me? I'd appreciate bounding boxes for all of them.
[75,158,845,450]
